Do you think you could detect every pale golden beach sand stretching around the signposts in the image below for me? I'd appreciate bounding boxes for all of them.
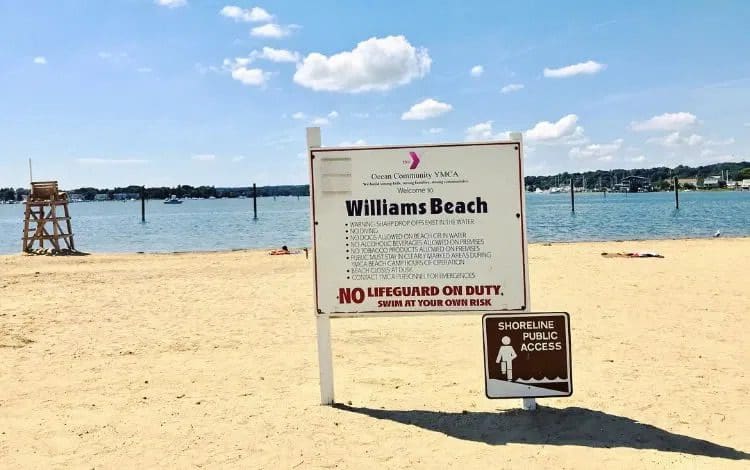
[0,239,750,469]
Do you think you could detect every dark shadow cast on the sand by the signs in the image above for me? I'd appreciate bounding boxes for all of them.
[334,404,750,460]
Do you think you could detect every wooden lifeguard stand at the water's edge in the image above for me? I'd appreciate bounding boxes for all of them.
[23,181,75,253]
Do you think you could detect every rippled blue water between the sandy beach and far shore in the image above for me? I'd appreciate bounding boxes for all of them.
[0,191,750,253]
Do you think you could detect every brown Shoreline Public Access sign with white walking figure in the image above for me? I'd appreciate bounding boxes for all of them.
[482,313,573,398]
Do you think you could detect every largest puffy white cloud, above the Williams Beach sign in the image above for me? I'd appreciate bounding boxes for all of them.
[294,36,432,93]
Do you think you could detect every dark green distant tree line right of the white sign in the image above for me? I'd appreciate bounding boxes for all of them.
[525,162,750,191]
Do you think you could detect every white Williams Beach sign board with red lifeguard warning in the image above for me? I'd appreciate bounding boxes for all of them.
[310,142,528,316]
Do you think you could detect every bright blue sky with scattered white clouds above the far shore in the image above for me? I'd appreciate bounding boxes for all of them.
[0,0,750,187]
